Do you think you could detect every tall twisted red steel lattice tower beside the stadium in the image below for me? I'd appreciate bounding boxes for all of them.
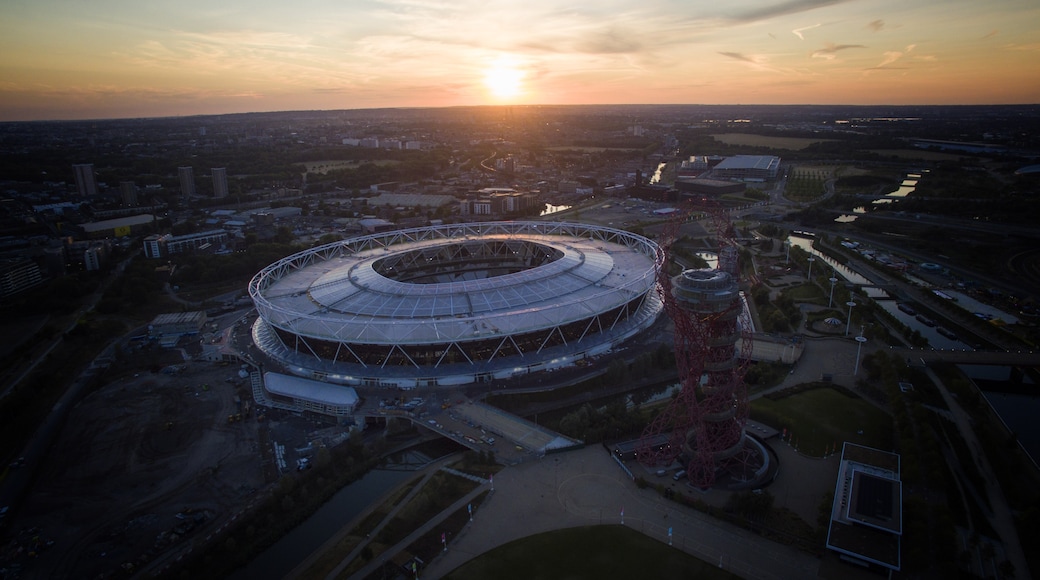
[638,202,760,487]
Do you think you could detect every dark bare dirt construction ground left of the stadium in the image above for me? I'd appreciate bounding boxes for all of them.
[16,362,270,578]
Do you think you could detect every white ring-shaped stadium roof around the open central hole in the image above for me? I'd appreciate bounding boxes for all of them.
[250,222,656,345]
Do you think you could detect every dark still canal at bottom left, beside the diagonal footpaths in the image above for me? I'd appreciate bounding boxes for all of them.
[229,451,433,580]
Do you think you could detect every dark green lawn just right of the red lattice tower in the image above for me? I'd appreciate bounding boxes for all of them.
[751,387,893,456]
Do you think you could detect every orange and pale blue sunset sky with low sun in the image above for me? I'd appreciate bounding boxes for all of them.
[0,0,1040,121]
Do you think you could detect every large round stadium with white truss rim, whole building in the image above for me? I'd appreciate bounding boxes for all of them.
[249,221,662,389]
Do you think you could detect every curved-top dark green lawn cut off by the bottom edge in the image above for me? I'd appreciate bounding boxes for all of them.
[444,526,738,580]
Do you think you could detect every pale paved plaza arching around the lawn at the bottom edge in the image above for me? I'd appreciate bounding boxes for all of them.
[422,446,819,580]
